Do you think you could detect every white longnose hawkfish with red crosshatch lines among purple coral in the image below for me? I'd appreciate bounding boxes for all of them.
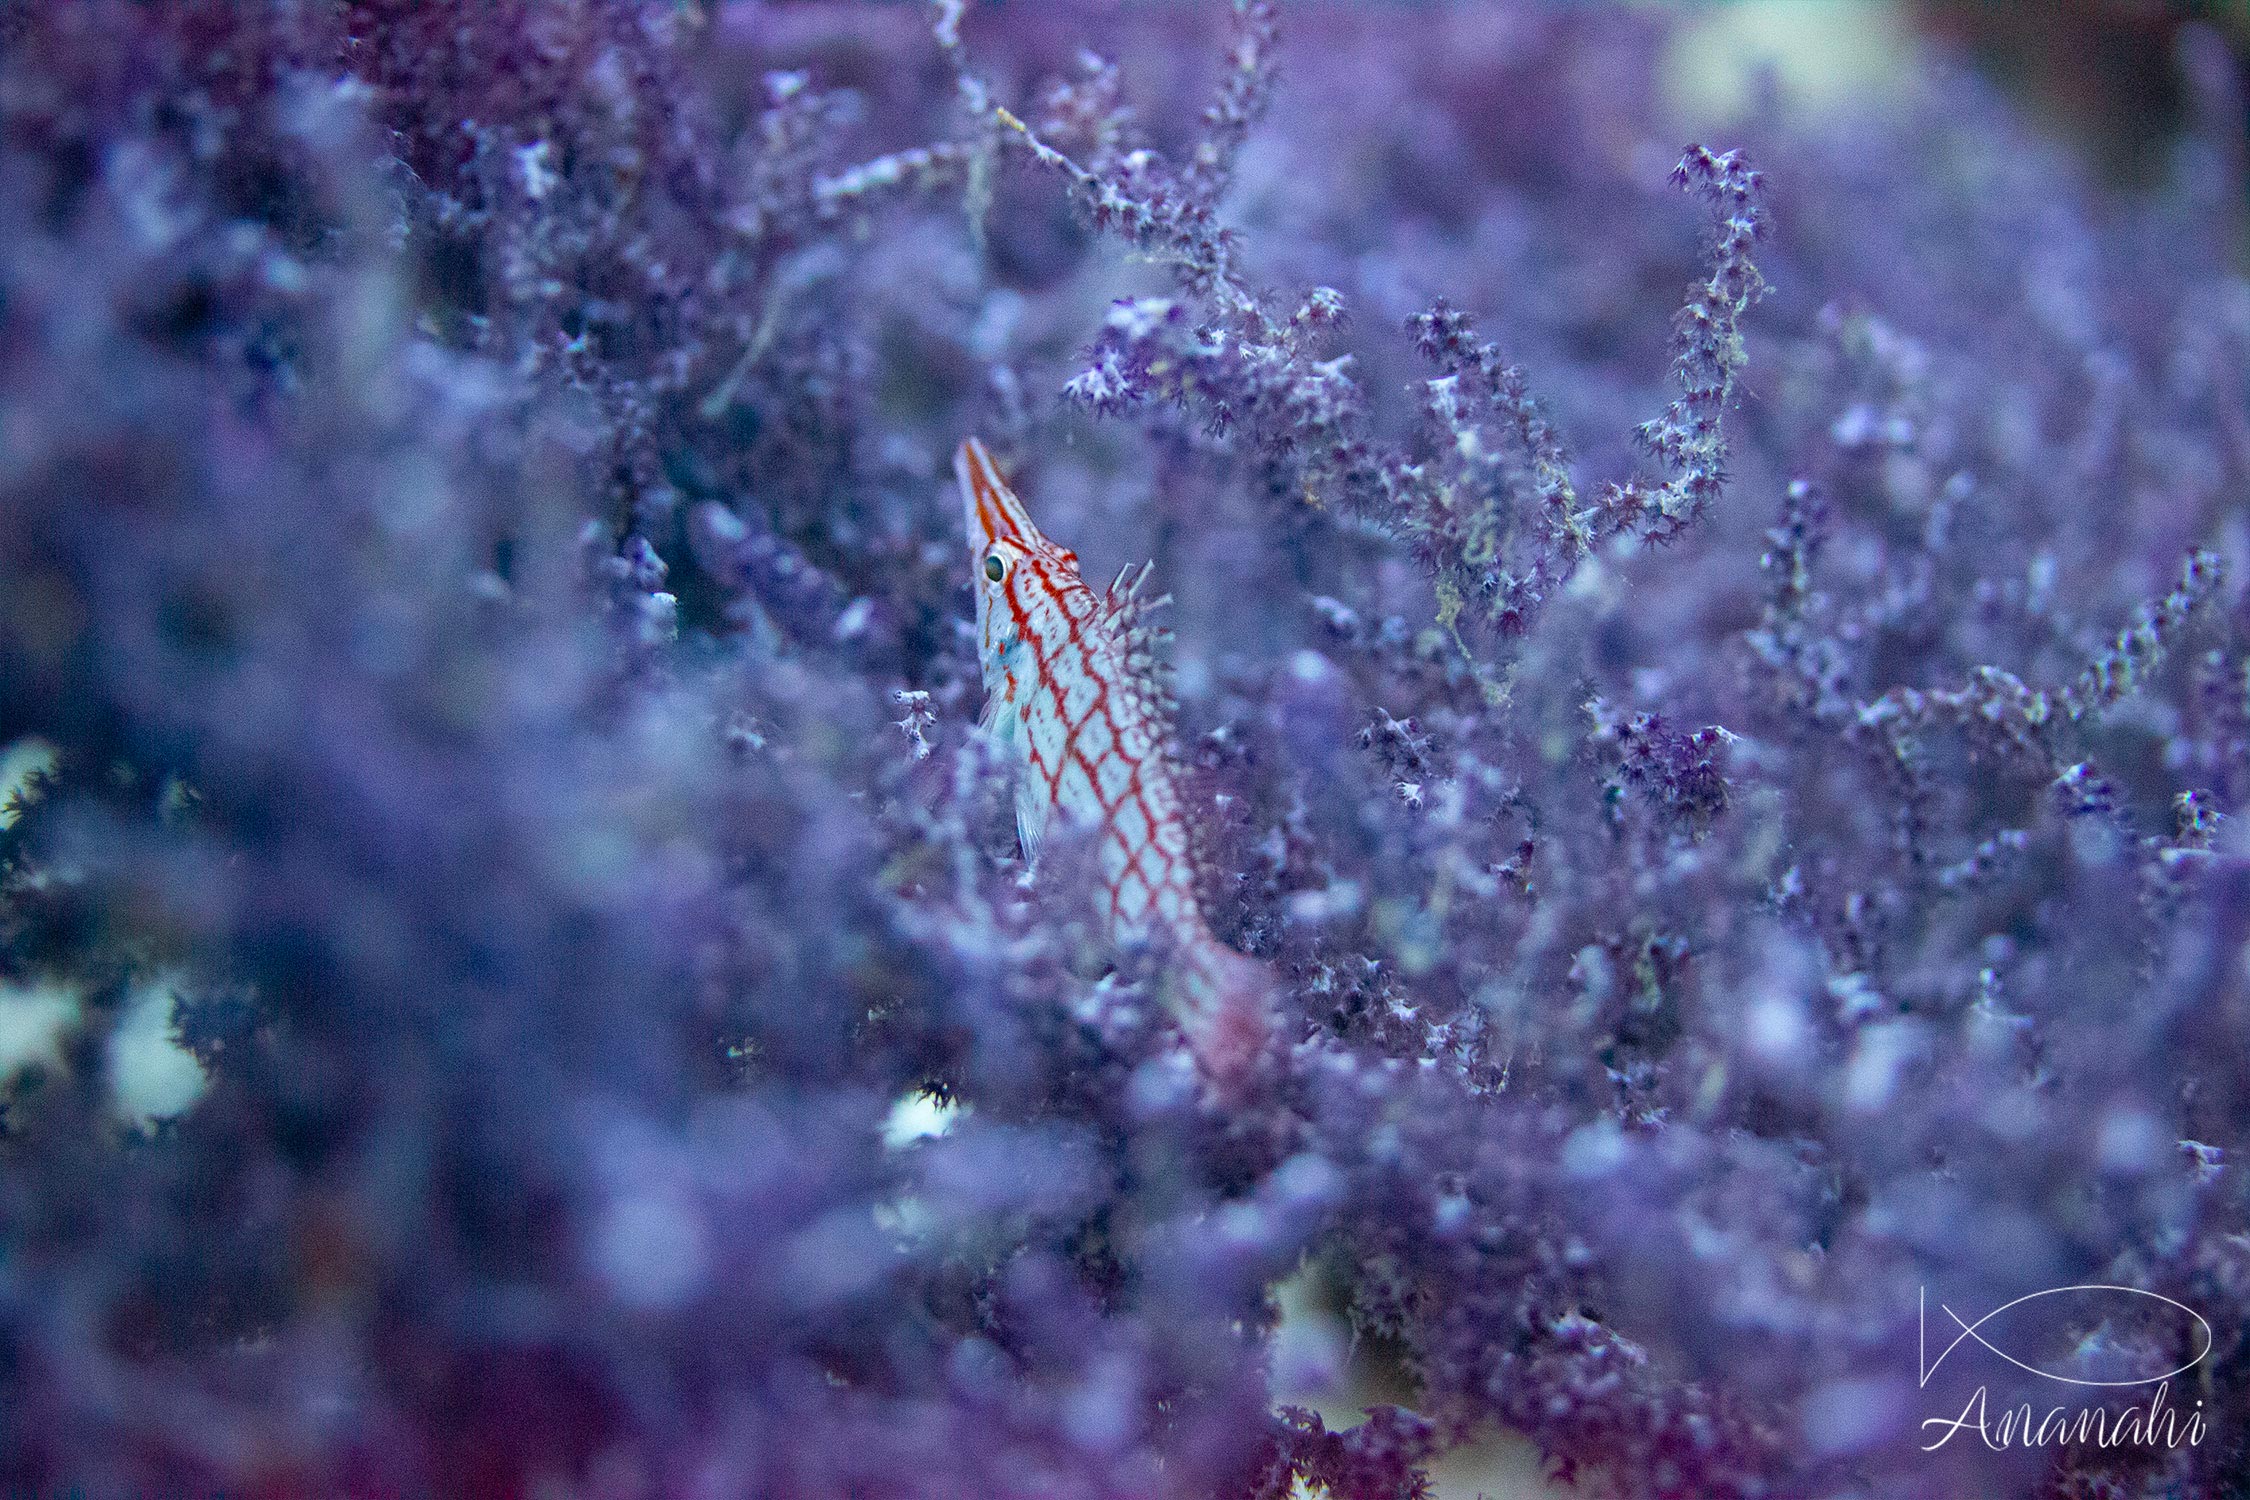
[954,439,1271,1086]
